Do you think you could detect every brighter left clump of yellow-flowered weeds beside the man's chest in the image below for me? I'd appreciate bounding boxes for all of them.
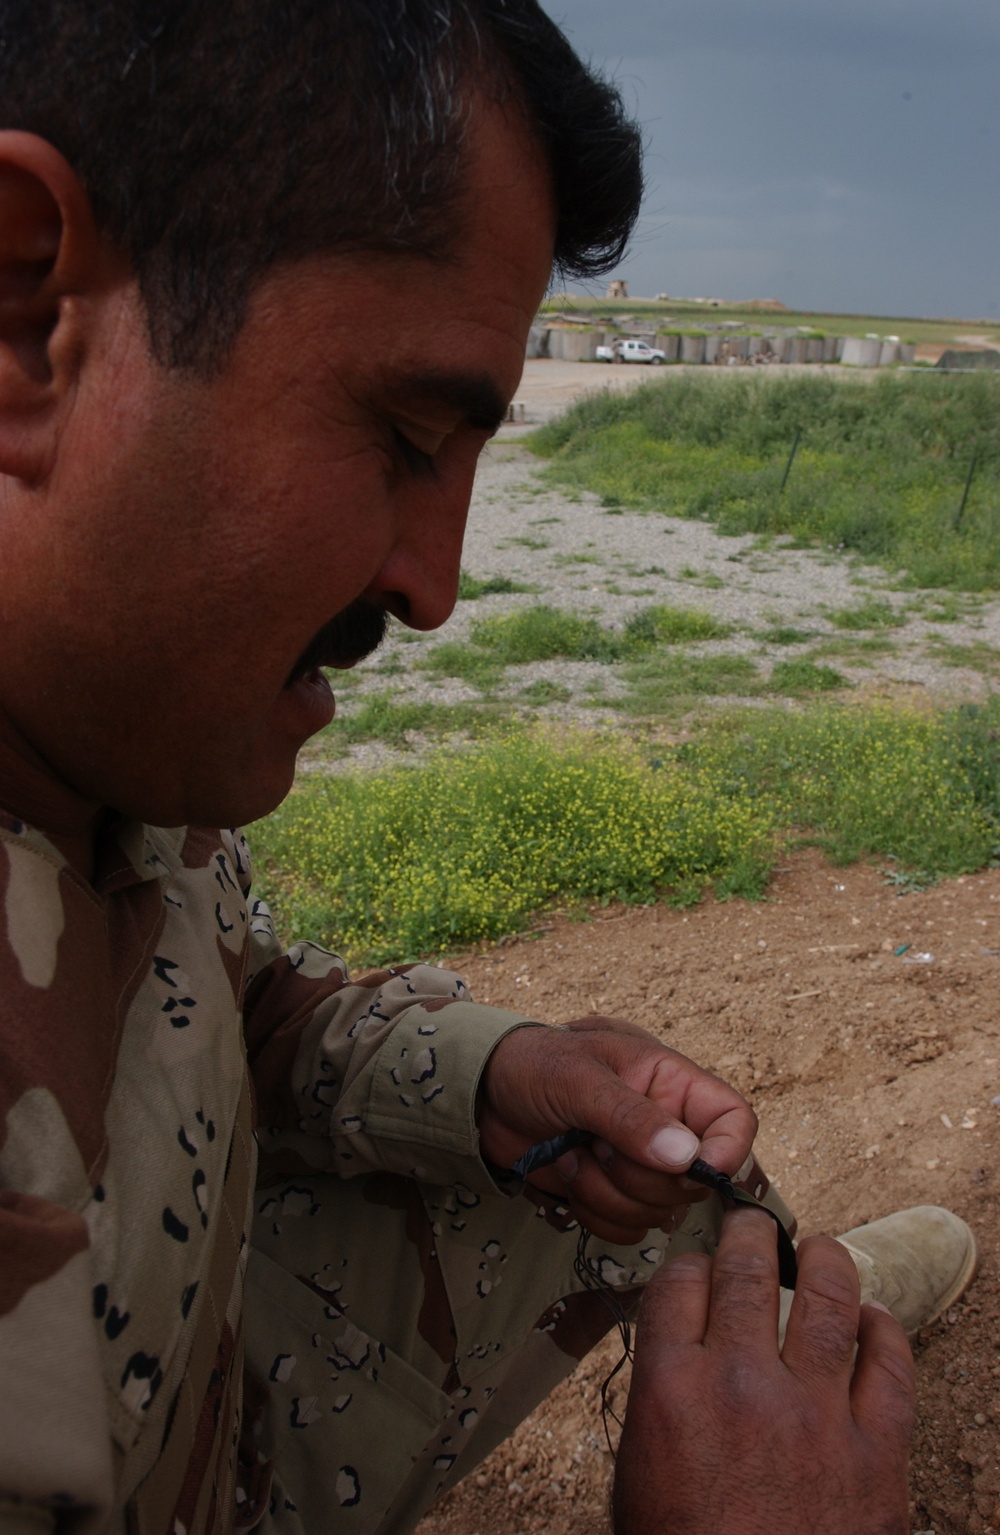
[255,734,774,962]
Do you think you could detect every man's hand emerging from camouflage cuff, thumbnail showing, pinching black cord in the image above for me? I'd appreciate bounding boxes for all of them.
[479,1018,757,1243]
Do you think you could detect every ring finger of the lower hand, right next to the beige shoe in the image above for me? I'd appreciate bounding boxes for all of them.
[782,1237,860,1382]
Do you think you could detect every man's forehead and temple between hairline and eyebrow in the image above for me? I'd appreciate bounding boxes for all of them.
[198,101,555,424]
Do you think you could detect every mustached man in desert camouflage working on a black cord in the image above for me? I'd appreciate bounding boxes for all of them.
[0,0,974,1535]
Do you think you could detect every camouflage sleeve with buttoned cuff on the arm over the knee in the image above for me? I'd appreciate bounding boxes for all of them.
[244,878,533,1193]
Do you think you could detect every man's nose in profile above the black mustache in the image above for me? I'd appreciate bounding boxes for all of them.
[364,470,475,629]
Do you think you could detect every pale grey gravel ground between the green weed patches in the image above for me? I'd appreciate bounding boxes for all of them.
[303,434,1000,771]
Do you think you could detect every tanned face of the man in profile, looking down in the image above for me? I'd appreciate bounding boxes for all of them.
[0,106,553,824]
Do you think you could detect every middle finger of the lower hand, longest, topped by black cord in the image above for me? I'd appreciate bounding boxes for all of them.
[707,1208,779,1355]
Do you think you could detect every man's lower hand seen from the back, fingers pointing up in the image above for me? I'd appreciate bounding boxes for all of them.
[614,1210,916,1535]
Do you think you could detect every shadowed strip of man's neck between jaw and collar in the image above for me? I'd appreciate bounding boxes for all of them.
[0,709,104,880]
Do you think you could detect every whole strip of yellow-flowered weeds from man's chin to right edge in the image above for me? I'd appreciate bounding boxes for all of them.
[253,705,1000,961]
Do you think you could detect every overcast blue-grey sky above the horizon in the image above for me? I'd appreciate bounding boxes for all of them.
[542,0,1000,321]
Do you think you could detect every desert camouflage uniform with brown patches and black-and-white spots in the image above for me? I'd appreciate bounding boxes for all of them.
[0,815,798,1535]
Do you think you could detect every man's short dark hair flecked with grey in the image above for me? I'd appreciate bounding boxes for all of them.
[0,0,642,370]
